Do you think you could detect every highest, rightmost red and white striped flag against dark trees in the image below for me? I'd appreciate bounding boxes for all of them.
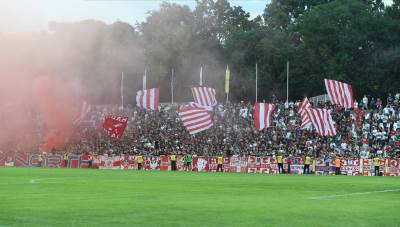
[325,79,354,109]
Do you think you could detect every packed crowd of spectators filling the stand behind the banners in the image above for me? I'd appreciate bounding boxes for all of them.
[65,94,400,158]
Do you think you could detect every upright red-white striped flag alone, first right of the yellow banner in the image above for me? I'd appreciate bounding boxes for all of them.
[254,103,275,131]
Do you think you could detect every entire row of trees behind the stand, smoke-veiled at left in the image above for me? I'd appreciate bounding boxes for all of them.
[0,0,400,104]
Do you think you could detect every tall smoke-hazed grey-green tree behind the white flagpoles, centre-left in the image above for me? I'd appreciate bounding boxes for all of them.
[139,3,224,101]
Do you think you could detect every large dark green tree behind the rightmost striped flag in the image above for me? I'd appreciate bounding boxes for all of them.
[293,0,398,96]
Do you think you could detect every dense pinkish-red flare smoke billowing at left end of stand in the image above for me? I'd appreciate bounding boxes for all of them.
[0,33,82,151]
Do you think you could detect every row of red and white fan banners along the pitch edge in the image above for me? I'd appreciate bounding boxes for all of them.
[0,152,400,176]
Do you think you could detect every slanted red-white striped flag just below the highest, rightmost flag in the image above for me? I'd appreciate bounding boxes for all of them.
[305,108,336,136]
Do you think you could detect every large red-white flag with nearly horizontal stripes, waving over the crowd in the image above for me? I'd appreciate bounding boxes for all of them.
[177,106,213,135]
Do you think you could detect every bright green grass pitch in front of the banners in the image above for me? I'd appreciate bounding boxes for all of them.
[0,168,400,226]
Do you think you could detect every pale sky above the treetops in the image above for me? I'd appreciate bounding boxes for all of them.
[0,0,269,32]
